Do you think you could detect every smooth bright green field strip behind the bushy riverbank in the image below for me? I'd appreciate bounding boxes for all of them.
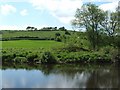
[2,40,63,49]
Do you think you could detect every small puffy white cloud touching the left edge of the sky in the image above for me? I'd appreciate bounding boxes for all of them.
[0,4,16,15]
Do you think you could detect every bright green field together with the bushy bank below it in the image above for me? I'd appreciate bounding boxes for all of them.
[2,40,118,63]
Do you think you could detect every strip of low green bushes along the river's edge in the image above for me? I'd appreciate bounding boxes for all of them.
[2,48,119,64]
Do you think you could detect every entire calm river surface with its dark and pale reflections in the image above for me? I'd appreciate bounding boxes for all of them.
[0,64,120,88]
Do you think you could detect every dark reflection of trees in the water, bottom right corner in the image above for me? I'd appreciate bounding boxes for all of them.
[87,64,119,88]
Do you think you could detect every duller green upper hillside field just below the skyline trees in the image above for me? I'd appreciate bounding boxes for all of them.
[2,31,65,38]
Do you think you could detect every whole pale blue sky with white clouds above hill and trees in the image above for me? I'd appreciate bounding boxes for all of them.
[0,0,119,30]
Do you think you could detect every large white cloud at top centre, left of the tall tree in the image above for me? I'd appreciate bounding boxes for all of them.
[30,0,82,24]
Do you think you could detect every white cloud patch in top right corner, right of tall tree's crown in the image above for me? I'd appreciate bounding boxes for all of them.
[99,2,118,12]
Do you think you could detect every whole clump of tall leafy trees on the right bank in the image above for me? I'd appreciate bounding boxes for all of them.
[72,3,119,50]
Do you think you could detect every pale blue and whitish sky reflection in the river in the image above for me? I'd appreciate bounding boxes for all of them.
[2,69,89,88]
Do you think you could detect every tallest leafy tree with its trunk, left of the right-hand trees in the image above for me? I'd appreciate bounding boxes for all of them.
[72,3,105,50]
